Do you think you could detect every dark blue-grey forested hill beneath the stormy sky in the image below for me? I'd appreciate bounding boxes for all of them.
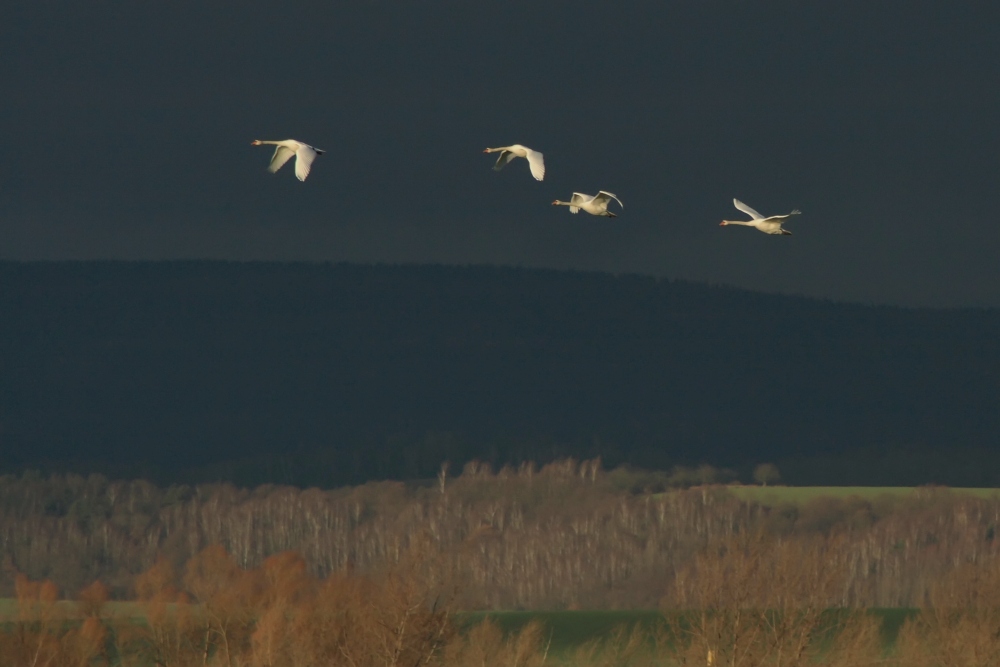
[0,262,1000,484]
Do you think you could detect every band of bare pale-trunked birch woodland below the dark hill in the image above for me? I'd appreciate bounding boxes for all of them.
[0,460,1000,609]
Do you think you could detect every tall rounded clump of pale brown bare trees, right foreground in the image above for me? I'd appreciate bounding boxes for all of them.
[664,531,881,667]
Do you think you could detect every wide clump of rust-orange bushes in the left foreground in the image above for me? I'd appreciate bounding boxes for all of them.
[116,546,455,667]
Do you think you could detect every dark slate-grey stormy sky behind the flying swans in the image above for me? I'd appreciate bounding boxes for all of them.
[0,0,1000,306]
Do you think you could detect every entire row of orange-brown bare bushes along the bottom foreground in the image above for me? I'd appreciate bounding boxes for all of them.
[7,530,1000,667]
